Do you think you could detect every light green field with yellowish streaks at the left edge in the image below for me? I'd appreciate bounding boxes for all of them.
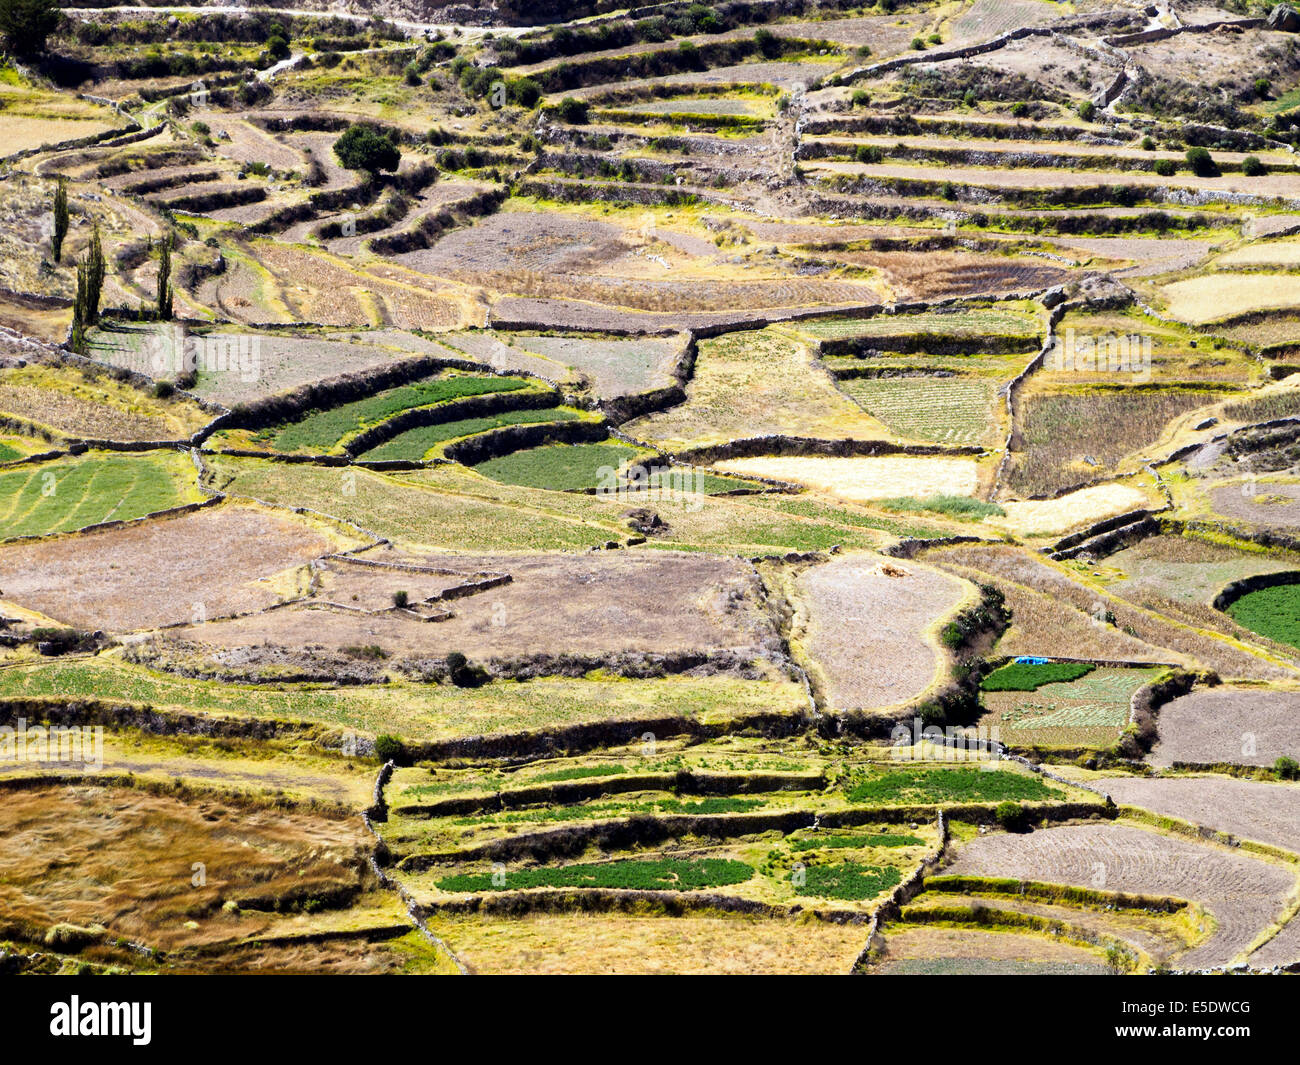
[0,451,203,537]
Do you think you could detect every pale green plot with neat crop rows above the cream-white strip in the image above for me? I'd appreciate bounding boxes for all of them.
[840,377,997,445]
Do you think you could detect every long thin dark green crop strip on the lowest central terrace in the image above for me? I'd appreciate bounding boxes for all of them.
[437,858,754,891]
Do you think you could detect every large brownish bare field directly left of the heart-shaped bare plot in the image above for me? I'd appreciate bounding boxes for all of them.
[152,551,779,672]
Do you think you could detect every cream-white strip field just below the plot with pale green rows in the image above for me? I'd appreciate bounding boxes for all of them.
[716,455,979,503]
